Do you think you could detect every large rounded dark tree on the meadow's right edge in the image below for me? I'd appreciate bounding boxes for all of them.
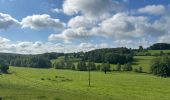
[151,56,170,77]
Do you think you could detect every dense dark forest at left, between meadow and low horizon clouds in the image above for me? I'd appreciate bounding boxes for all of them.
[0,53,64,68]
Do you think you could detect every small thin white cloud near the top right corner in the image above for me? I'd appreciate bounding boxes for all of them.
[138,5,166,15]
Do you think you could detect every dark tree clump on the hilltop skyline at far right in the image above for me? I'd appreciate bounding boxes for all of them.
[148,43,170,50]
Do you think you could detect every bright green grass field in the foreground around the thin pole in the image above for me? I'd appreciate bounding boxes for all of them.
[0,67,170,100]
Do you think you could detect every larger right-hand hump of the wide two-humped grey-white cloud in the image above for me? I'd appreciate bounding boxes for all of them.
[92,13,163,39]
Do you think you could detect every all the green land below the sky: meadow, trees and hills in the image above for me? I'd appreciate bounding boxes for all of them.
[0,43,170,100]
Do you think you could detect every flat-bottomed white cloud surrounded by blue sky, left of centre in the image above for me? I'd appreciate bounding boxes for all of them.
[21,14,65,29]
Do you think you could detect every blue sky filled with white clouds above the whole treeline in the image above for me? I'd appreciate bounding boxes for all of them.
[0,0,170,54]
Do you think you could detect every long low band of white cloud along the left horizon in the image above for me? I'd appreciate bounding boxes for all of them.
[0,37,111,54]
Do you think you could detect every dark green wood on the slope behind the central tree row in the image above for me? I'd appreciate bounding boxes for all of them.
[82,48,133,64]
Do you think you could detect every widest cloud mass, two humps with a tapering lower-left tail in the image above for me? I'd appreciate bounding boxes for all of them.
[49,13,166,40]
